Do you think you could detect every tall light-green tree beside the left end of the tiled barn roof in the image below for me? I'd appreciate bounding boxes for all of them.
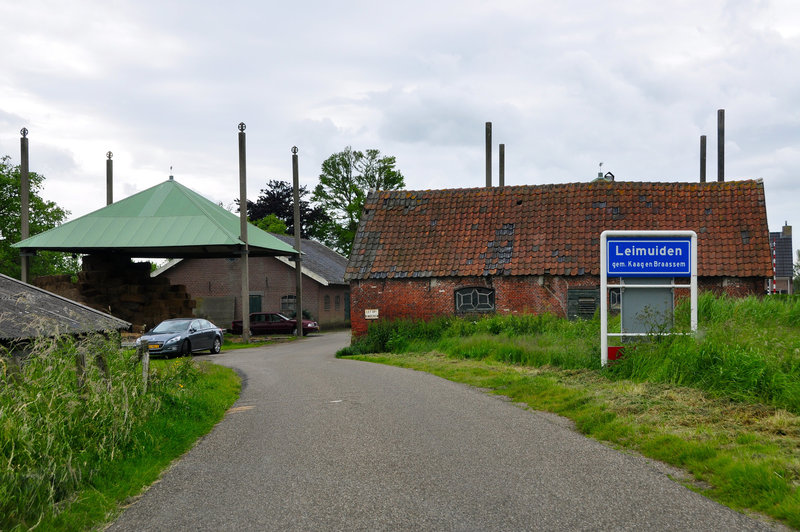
[312,146,405,255]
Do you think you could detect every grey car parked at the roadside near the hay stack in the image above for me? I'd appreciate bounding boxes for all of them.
[136,318,224,356]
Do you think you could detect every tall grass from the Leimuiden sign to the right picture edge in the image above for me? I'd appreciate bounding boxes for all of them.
[609,293,800,413]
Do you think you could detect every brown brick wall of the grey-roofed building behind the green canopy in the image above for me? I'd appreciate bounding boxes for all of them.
[161,257,349,327]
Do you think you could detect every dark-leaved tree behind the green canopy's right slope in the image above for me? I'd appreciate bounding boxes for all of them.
[236,179,328,239]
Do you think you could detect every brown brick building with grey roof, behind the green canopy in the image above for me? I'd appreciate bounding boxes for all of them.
[152,233,350,328]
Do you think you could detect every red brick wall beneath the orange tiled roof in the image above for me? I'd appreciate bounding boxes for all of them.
[350,275,764,336]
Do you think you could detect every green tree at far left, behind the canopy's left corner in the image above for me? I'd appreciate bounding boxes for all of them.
[0,155,78,279]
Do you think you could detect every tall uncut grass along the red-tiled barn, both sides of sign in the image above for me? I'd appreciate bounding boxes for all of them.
[339,293,800,413]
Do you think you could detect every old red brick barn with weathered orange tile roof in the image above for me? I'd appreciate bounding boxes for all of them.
[345,180,772,336]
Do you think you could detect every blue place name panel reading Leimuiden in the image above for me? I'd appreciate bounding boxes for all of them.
[606,237,692,277]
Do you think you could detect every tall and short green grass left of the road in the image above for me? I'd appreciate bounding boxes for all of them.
[0,337,240,530]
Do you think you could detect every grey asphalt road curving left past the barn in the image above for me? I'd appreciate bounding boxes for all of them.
[110,333,780,531]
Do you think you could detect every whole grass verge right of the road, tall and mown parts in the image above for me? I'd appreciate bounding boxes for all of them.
[339,294,800,528]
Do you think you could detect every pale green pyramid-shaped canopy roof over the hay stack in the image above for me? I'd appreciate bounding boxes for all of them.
[14,179,297,258]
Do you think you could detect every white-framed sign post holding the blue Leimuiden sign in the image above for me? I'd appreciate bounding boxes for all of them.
[600,231,697,366]
